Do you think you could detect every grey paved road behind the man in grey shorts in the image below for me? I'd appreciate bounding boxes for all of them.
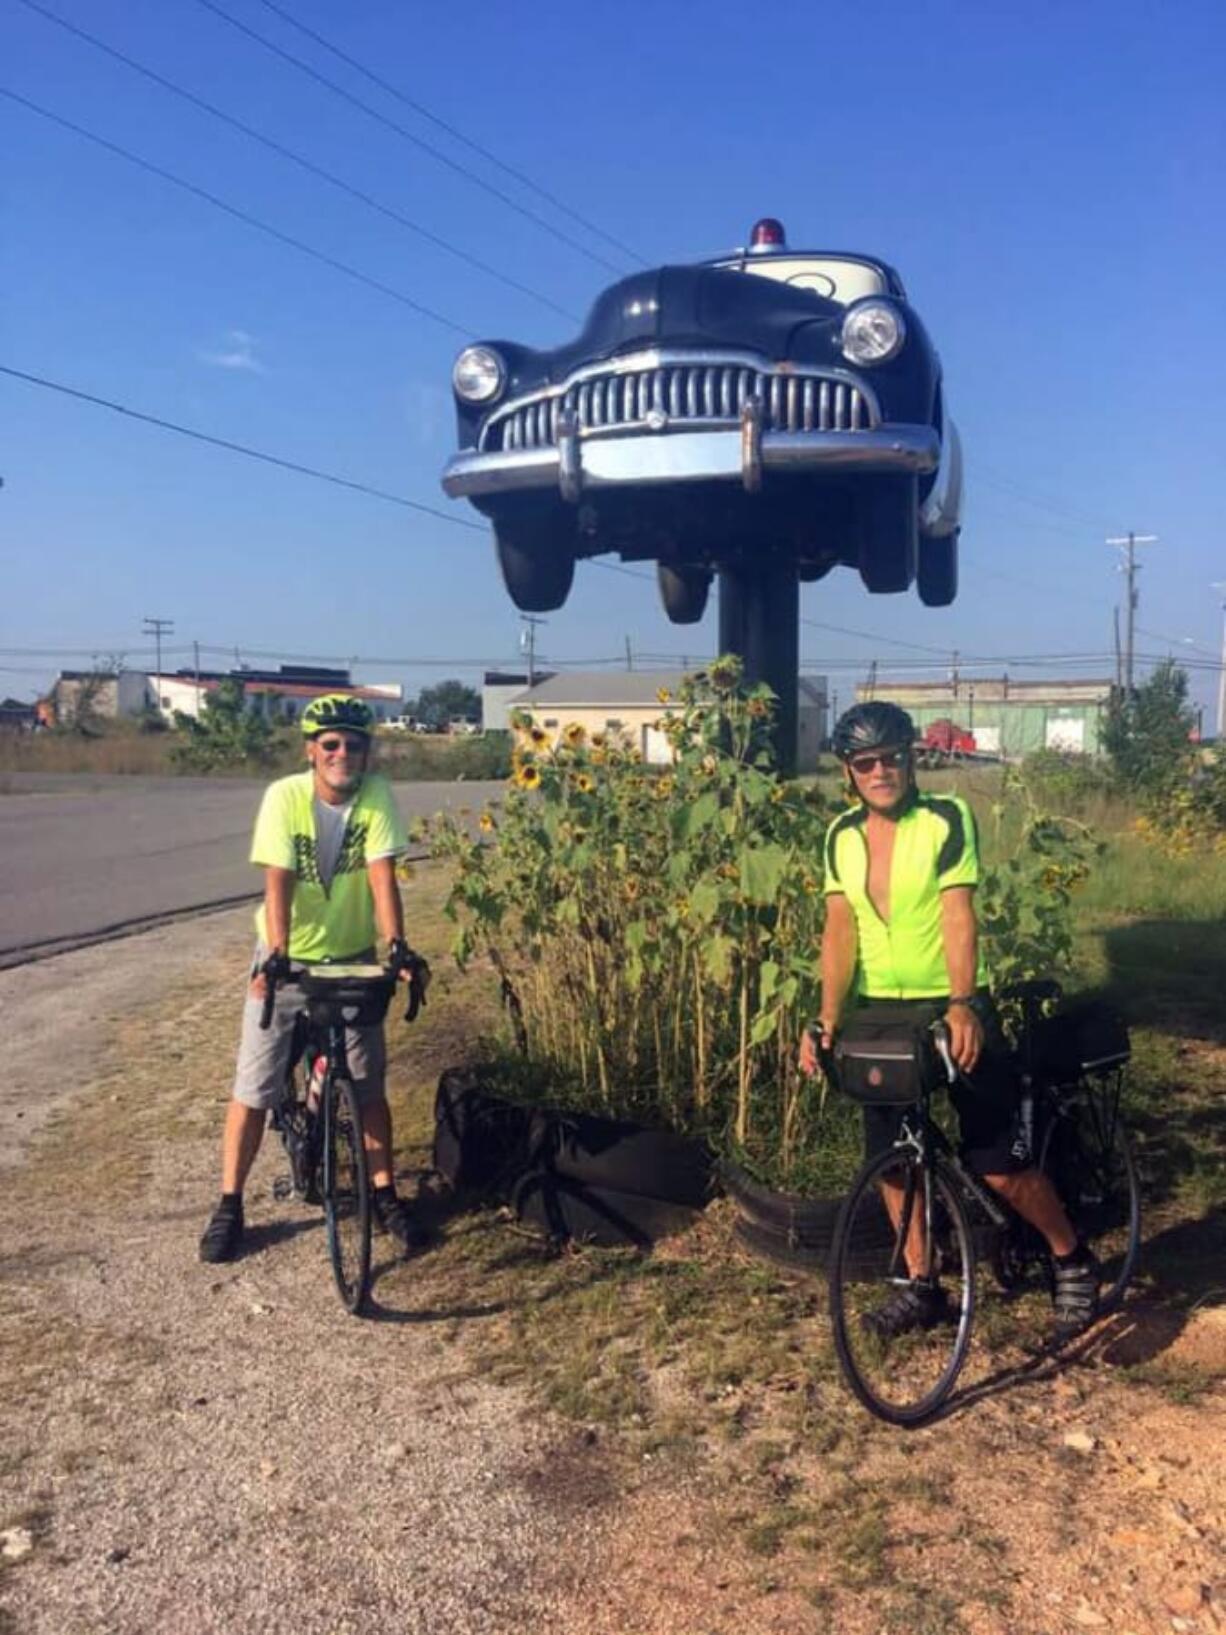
[0,773,503,965]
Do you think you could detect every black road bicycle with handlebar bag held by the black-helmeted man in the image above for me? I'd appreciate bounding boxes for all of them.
[824,981,1141,1426]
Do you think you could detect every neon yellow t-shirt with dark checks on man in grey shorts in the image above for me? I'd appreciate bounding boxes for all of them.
[252,770,409,963]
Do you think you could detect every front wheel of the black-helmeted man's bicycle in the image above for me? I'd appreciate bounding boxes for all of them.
[830,1148,974,1426]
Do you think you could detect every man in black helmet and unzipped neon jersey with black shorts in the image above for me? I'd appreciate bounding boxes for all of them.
[801,701,1098,1336]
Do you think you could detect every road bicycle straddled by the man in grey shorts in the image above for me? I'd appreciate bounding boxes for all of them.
[260,955,428,1316]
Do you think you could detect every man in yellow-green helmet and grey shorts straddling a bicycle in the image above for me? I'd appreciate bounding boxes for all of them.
[199,693,422,1262]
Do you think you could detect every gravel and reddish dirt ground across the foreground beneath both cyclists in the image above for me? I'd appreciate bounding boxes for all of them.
[0,912,1226,1635]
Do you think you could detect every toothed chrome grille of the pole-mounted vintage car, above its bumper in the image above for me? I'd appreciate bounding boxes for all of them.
[481,355,879,453]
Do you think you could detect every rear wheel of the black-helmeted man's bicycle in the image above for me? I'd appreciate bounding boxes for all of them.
[1040,1079,1141,1311]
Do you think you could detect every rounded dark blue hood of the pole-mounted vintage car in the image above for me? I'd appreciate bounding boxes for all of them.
[495,267,843,396]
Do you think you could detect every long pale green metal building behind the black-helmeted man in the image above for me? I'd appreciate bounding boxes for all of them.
[855,675,1115,760]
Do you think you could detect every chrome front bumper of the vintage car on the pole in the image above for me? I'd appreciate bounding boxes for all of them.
[443,404,942,500]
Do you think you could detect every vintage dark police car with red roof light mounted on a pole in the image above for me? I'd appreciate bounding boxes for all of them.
[443,219,961,623]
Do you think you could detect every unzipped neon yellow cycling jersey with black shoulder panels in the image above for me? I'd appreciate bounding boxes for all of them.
[826,795,987,999]
